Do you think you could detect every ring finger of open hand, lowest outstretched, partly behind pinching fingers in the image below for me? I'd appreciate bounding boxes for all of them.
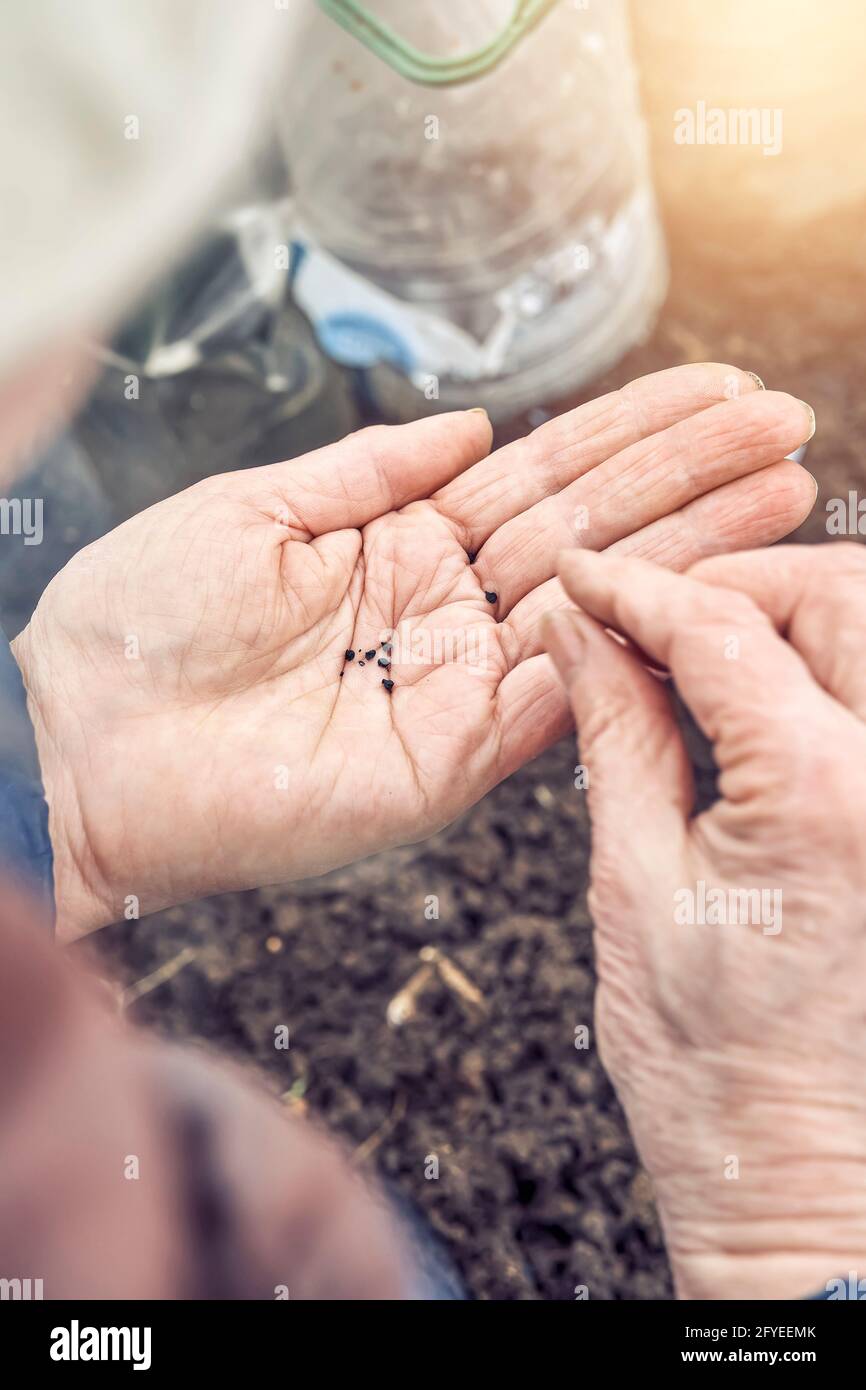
[607,460,817,571]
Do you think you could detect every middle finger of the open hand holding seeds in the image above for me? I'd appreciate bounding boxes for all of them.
[467,391,812,614]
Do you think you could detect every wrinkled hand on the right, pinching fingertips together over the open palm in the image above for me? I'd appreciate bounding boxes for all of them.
[545,545,866,1298]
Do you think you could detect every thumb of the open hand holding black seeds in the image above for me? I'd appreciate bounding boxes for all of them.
[254,410,493,539]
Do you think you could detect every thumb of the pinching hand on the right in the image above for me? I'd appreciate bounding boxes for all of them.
[544,609,694,845]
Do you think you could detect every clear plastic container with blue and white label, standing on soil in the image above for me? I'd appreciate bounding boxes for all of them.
[281,0,667,418]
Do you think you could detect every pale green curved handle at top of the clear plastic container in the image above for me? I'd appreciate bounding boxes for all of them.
[318,0,559,86]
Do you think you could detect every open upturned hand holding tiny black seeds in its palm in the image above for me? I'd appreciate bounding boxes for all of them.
[15,366,815,935]
